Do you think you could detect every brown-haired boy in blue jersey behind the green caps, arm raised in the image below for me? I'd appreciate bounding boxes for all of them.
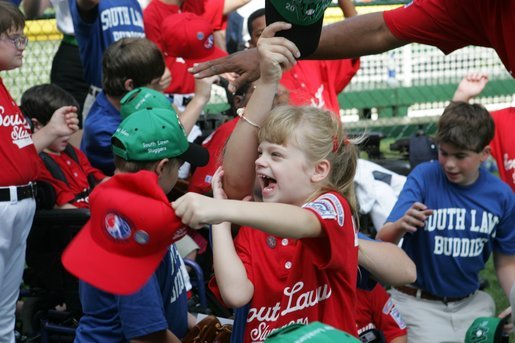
[80,38,216,175]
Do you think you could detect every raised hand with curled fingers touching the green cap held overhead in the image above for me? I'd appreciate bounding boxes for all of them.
[257,21,300,82]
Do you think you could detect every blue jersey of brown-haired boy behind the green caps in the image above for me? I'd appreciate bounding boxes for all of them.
[80,92,122,175]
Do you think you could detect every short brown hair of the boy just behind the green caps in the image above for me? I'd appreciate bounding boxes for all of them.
[102,38,165,97]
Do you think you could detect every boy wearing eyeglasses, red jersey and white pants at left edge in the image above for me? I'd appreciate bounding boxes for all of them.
[0,1,78,342]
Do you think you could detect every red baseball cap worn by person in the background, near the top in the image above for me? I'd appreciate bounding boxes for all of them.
[161,12,227,65]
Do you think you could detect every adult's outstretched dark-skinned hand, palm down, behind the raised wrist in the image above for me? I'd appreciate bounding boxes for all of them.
[188,48,259,93]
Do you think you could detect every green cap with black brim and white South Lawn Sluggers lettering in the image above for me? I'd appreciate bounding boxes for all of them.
[111,108,209,167]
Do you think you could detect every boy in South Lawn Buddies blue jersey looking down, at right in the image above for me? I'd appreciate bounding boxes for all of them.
[377,102,515,342]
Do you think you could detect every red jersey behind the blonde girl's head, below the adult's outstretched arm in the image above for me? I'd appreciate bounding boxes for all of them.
[281,59,360,114]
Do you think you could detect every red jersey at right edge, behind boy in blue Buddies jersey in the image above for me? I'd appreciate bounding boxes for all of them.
[490,107,515,192]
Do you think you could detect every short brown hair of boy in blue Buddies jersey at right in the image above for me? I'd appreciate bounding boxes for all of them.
[436,101,495,152]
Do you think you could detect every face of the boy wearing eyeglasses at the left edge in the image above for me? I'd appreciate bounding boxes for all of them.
[0,29,26,70]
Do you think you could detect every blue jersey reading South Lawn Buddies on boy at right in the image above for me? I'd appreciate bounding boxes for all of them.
[386,162,515,297]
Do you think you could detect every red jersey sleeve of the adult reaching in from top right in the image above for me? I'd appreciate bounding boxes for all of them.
[384,0,515,76]
